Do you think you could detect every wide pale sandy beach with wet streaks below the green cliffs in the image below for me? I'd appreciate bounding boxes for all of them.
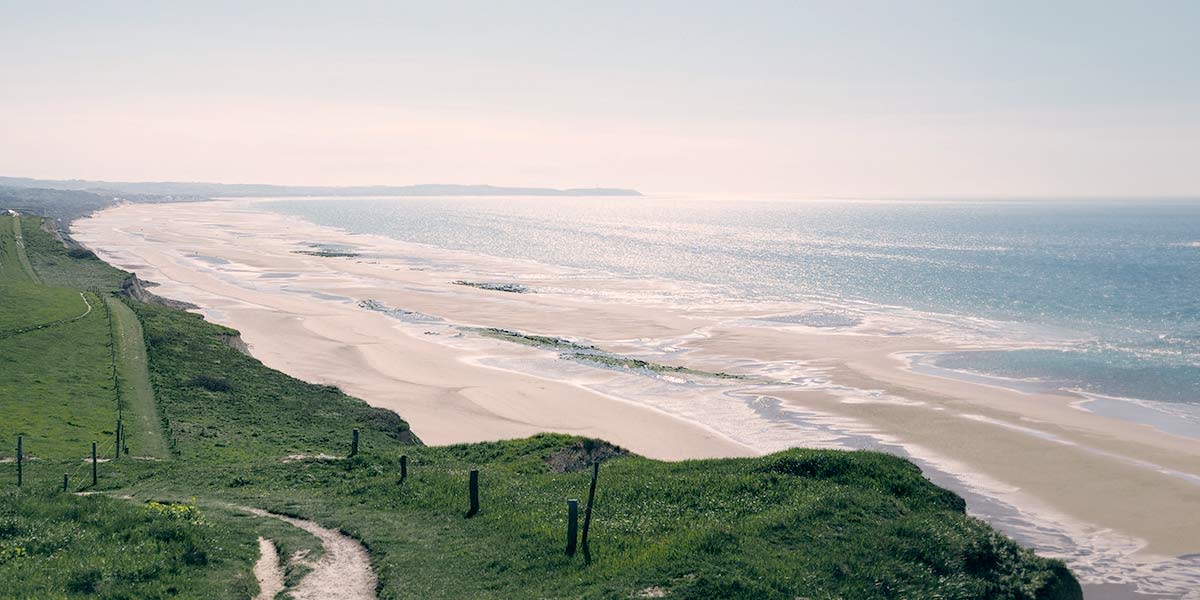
[72,200,1200,596]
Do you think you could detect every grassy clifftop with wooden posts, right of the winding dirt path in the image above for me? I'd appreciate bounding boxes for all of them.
[119,436,1078,599]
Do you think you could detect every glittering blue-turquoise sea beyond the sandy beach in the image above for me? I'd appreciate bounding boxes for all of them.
[265,197,1200,404]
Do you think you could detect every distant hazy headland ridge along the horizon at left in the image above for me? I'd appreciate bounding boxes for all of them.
[0,176,642,198]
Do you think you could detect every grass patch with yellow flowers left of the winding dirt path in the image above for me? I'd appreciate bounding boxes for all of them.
[0,488,319,600]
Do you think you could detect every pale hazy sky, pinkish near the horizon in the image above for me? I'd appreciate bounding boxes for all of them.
[0,0,1200,197]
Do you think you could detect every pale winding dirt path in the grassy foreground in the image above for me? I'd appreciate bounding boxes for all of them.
[238,506,376,600]
